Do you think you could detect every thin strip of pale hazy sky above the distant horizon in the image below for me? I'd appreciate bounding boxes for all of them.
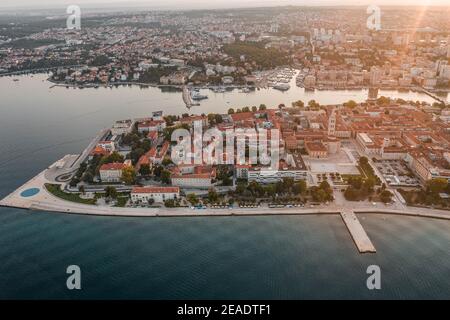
[0,0,450,9]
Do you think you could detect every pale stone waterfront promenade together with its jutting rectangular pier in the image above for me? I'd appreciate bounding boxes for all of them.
[0,155,450,254]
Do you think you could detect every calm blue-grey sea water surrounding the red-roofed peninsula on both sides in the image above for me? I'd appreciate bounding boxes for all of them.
[0,75,450,299]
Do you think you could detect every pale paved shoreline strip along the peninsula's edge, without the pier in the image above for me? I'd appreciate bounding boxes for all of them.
[0,164,450,221]
